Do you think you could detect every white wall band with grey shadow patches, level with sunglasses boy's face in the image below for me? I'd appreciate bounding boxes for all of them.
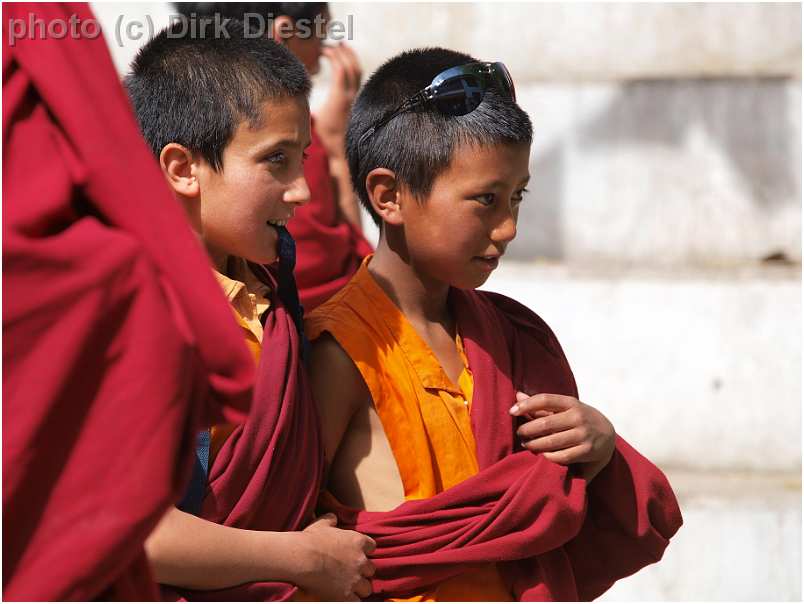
[511,78,801,267]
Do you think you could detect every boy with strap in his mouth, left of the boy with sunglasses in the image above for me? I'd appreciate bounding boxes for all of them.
[125,21,373,600]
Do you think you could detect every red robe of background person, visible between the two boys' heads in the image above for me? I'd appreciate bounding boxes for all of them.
[287,121,374,313]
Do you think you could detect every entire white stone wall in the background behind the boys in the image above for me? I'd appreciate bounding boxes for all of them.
[92,3,801,600]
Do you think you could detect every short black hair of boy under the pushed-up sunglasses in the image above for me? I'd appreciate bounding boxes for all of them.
[346,48,533,226]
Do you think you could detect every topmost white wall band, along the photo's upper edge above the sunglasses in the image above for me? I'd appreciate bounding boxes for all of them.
[331,2,801,81]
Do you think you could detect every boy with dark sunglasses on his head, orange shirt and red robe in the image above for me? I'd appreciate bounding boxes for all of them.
[306,49,681,601]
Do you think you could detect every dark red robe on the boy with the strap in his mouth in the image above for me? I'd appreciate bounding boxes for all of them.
[170,265,324,601]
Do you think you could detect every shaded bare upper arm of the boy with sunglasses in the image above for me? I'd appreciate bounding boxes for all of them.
[310,332,370,462]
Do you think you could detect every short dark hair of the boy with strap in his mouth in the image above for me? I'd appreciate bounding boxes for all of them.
[124,20,310,170]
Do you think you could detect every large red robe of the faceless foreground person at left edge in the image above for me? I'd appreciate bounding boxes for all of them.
[3,4,254,600]
